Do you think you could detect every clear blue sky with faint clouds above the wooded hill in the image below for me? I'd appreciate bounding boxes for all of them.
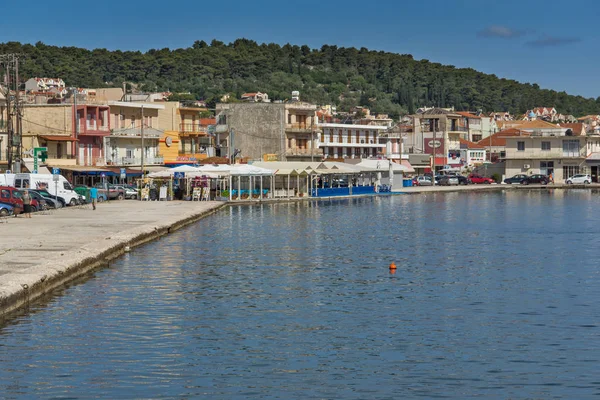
[0,0,600,98]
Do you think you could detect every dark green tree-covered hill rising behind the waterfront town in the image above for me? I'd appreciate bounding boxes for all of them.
[0,39,600,117]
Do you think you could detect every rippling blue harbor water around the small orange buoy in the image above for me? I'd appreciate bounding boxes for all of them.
[0,190,600,399]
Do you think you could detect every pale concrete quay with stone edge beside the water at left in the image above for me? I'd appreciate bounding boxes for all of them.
[0,200,225,316]
